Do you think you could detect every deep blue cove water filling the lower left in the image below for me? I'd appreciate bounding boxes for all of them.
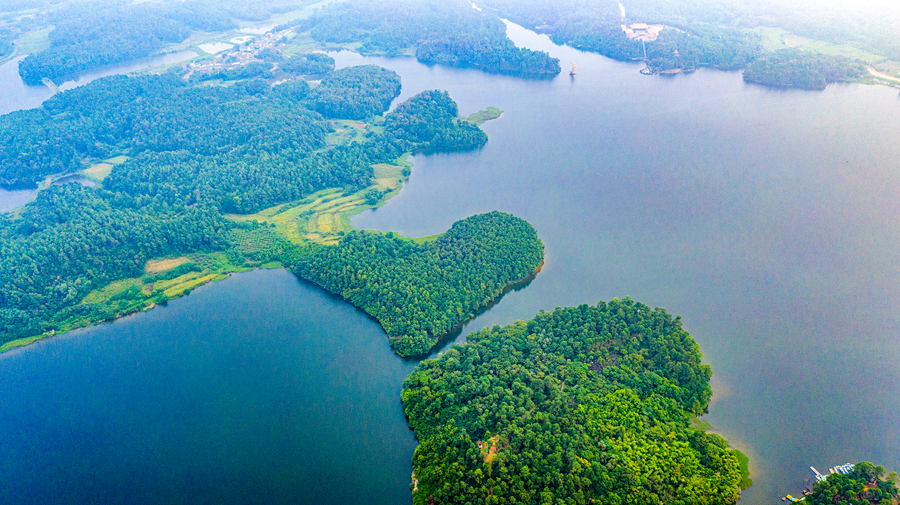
[0,270,416,505]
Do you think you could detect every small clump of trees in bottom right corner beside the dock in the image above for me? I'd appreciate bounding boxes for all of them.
[805,461,898,505]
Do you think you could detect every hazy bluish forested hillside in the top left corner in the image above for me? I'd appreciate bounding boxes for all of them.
[19,0,313,85]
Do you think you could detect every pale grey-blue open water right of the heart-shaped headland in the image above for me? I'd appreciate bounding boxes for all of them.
[350,22,900,504]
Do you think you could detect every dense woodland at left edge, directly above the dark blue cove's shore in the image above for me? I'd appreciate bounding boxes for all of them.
[0,183,228,344]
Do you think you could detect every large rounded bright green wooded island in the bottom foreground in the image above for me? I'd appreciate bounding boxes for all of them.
[402,298,741,505]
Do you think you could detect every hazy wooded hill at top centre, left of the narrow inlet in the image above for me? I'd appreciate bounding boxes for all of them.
[298,0,560,78]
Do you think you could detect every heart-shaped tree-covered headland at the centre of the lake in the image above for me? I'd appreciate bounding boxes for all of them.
[292,212,544,356]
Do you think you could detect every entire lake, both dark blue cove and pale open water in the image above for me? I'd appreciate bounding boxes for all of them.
[0,21,900,504]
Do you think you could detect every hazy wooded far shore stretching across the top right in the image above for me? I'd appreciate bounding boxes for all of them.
[483,0,888,89]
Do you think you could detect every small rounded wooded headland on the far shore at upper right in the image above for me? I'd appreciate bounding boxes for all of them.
[744,49,866,89]
